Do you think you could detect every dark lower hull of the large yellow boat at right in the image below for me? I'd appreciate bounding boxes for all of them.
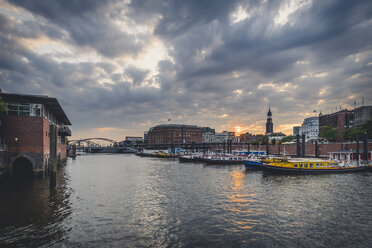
[261,164,367,174]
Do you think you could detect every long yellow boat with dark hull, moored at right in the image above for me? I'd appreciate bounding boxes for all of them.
[261,158,367,173]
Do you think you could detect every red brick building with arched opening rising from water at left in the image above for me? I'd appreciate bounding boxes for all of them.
[0,91,71,176]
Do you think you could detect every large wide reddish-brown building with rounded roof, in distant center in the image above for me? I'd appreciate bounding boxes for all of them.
[148,124,203,144]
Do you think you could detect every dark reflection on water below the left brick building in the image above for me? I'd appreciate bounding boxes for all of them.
[0,164,71,247]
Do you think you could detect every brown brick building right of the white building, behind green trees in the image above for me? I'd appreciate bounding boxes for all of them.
[319,109,353,141]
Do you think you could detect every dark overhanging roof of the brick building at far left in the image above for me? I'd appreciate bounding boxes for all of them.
[0,92,71,125]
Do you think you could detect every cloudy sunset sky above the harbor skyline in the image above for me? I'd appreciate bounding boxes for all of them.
[0,0,372,141]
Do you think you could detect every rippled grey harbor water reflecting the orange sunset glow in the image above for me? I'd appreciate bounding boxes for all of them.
[0,154,372,247]
